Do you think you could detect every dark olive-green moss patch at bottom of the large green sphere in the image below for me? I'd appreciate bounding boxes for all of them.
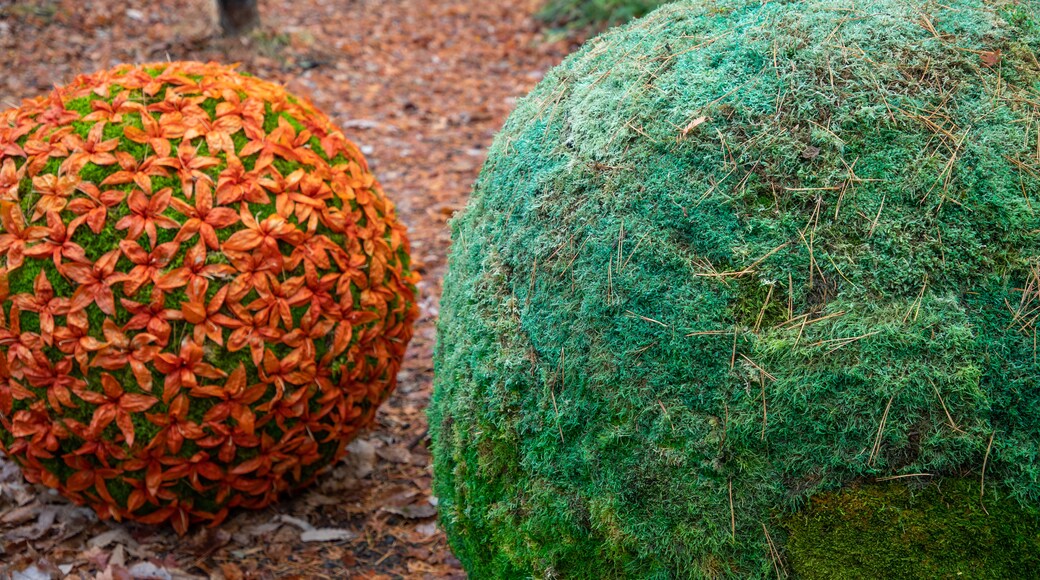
[783,479,1040,579]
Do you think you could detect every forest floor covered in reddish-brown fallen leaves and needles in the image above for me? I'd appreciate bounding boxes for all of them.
[0,0,574,580]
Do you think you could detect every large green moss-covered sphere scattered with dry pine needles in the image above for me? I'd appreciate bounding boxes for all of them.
[430,0,1040,578]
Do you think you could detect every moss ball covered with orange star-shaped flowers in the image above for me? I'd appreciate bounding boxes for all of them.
[0,62,417,533]
